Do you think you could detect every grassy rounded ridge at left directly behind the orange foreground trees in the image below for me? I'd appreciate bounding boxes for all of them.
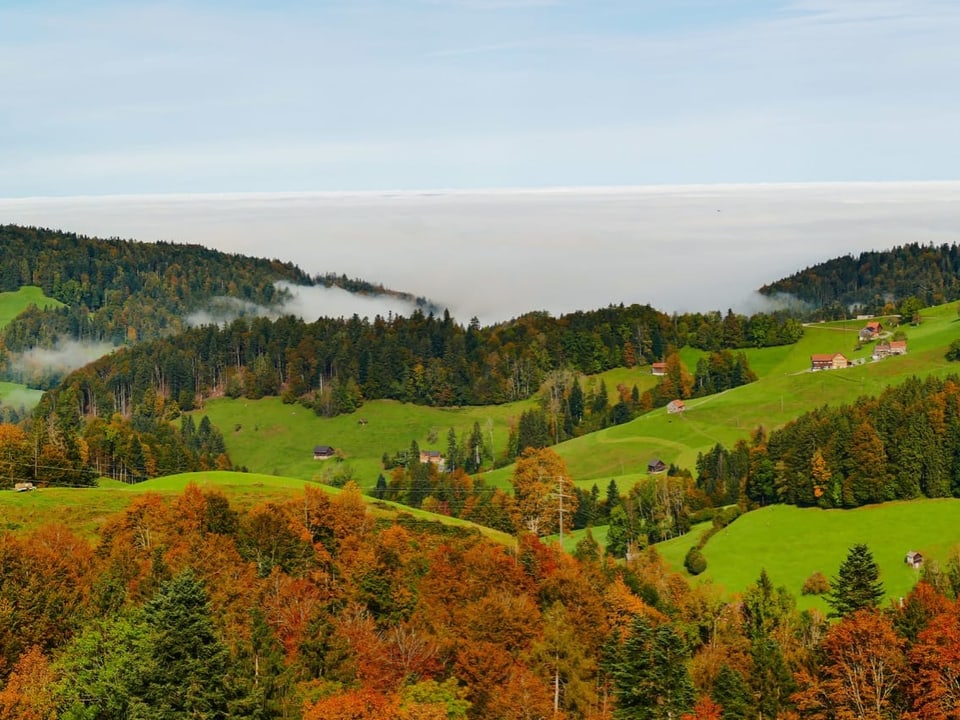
[0,471,514,545]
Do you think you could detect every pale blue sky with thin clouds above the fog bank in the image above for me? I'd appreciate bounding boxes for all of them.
[0,0,960,197]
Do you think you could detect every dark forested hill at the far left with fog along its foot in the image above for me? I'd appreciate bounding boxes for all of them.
[0,225,425,352]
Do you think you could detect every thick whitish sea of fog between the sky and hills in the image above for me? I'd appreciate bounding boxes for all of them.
[0,182,960,324]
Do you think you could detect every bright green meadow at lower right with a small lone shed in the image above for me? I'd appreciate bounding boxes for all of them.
[657,499,960,611]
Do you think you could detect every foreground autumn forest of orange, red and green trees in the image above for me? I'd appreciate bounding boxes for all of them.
[0,483,960,720]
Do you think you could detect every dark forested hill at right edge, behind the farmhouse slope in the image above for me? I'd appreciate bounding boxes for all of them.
[760,243,960,317]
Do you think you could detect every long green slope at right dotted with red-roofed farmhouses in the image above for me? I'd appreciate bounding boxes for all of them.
[489,305,960,487]
